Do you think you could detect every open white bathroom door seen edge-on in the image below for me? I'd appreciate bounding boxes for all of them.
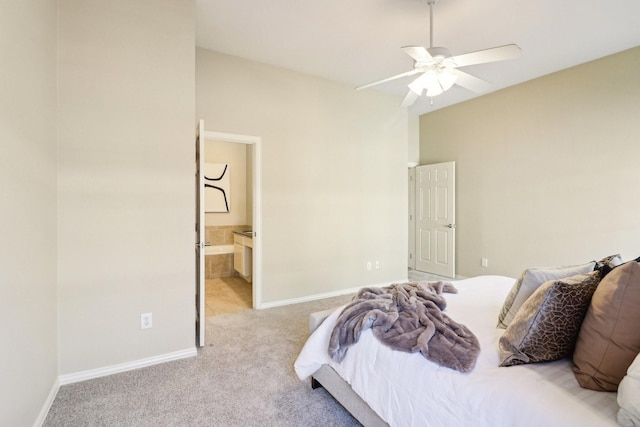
[195,120,207,347]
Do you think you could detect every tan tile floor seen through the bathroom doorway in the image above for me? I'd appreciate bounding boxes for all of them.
[205,277,252,317]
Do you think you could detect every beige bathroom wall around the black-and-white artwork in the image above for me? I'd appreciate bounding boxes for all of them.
[205,141,251,225]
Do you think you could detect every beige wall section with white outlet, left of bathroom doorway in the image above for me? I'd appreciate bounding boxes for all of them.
[58,0,196,375]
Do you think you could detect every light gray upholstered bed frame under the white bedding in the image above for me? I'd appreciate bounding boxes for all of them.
[309,309,389,427]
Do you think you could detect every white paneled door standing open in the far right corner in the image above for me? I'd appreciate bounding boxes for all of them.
[415,162,456,277]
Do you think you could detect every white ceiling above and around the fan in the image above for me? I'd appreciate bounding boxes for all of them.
[196,0,640,114]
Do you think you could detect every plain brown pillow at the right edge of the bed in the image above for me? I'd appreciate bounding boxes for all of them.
[573,261,640,391]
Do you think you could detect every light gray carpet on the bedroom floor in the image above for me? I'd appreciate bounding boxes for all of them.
[44,296,359,427]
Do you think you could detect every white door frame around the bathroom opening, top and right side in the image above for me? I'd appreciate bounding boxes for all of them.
[204,130,262,309]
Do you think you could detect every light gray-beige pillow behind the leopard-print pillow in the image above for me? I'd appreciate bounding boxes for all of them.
[498,261,596,328]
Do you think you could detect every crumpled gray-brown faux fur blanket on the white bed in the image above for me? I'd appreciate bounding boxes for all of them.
[329,282,480,372]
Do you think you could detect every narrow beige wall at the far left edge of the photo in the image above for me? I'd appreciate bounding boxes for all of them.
[0,0,58,426]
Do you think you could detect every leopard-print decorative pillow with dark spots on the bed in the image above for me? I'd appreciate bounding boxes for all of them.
[498,271,600,366]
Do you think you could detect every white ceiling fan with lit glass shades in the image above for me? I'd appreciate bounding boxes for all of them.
[356,0,521,107]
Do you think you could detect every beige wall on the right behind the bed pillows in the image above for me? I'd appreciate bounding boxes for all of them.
[420,48,640,276]
